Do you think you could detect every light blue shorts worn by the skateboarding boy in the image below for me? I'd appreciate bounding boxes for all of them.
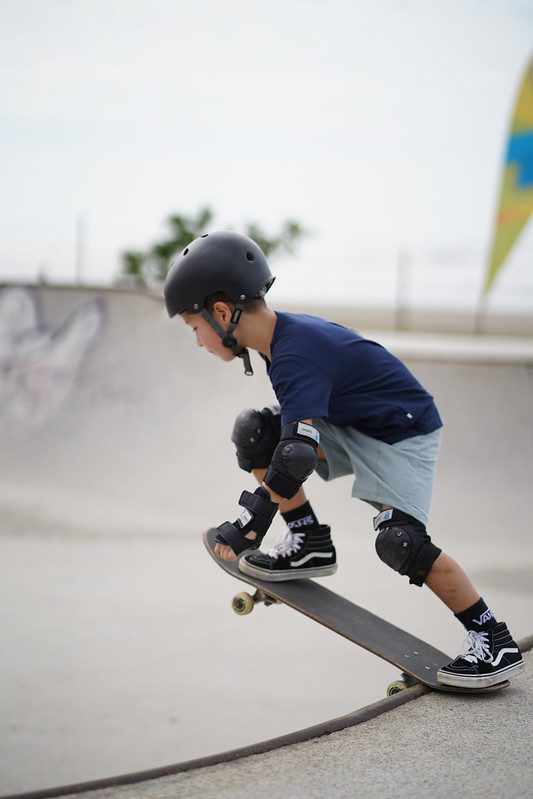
[313,419,442,524]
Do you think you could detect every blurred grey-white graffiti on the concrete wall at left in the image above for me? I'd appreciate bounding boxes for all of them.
[0,287,104,429]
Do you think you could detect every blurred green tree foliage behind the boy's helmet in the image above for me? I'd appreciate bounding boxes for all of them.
[117,206,305,288]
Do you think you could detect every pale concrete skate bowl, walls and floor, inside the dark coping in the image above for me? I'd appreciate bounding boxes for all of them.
[0,289,533,794]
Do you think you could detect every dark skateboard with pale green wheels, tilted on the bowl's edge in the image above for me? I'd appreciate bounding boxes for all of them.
[203,528,509,696]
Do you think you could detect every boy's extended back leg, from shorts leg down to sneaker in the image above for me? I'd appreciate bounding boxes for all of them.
[347,418,524,688]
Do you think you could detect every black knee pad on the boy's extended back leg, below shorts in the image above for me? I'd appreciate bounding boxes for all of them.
[374,509,442,586]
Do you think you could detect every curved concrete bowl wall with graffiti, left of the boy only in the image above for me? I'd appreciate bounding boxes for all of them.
[0,288,271,535]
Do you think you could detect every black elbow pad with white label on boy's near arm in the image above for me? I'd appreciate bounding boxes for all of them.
[264,422,320,499]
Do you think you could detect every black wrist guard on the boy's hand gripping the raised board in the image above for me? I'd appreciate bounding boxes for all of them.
[215,486,278,555]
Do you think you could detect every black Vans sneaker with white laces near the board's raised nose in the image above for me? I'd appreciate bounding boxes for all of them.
[239,524,337,582]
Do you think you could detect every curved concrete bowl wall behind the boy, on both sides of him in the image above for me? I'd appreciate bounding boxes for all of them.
[0,286,533,535]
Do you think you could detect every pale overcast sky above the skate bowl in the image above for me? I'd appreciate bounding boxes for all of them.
[0,0,533,306]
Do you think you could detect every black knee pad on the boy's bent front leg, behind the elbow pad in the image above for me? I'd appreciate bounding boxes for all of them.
[231,406,281,472]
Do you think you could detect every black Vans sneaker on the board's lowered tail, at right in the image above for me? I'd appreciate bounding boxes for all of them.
[437,621,524,688]
